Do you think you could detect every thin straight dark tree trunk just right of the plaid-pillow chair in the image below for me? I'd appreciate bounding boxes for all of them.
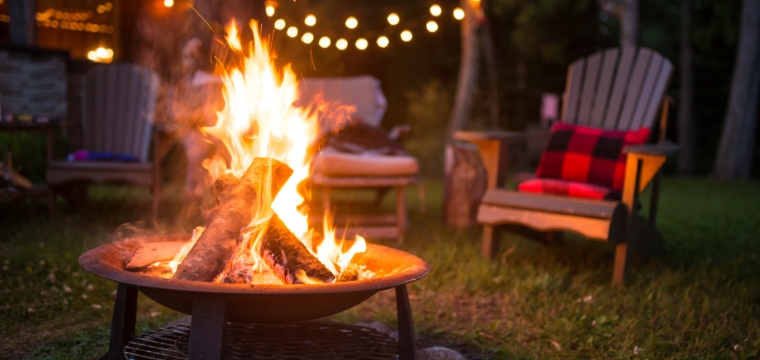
[678,0,694,175]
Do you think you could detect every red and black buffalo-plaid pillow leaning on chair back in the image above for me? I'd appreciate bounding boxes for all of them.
[536,123,649,191]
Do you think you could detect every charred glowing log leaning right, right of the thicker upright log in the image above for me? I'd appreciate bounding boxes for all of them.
[259,214,334,284]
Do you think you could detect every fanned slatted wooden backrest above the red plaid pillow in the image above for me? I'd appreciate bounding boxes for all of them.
[562,47,673,131]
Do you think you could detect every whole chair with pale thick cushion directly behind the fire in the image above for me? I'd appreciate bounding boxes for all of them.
[300,76,419,243]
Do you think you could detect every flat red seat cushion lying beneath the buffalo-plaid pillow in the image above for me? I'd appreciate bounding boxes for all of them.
[517,179,620,200]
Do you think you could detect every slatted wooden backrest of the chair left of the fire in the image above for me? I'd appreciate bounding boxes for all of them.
[82,64,158,162]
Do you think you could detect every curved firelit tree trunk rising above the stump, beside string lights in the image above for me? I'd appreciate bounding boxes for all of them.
[448,0,480,139]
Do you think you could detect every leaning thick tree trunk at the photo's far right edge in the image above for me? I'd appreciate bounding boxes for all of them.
[715,0,760,179]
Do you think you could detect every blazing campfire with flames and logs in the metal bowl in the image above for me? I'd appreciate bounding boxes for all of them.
[127,21,374,284]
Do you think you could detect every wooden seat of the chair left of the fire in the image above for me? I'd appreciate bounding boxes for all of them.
[47,161,153,186]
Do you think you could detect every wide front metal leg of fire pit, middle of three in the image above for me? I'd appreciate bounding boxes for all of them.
[189,298,227,360]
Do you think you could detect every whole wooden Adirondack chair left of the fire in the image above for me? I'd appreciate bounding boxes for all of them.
[47,64,159,218]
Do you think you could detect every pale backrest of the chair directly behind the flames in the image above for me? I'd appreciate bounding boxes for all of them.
[299,76,388,127]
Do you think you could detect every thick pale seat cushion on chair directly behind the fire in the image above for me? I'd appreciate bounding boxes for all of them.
[312,149,419,176]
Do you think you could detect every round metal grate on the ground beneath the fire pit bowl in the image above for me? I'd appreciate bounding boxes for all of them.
[124,321,398,360]
